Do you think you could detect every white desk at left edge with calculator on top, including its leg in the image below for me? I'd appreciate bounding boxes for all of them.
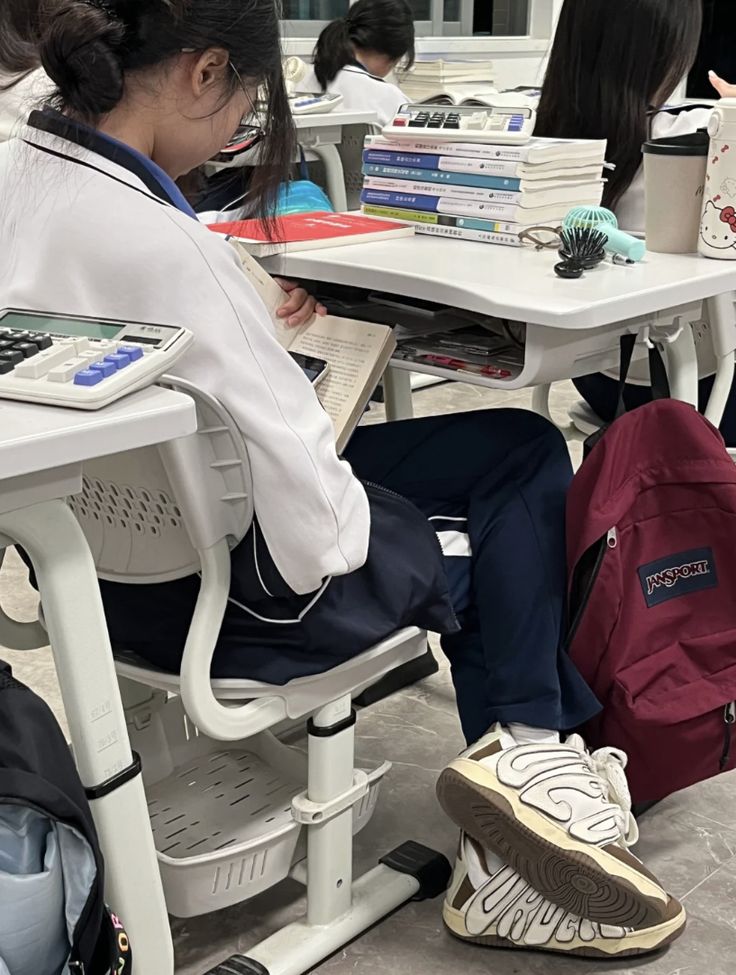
[0,387,197,975]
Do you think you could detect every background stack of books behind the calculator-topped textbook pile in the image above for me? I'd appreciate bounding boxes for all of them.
[401,60,496,105]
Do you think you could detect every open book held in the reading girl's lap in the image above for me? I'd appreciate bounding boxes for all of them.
[230,240,396,453]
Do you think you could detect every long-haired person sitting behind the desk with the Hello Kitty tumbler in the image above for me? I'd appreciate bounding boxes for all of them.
[535,0,736,436]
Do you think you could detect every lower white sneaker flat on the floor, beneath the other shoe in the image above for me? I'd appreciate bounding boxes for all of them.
[442,835,686,958]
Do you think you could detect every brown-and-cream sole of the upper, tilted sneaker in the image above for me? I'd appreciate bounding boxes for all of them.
[437,759,669,928]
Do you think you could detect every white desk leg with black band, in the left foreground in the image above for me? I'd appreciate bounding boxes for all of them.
[0,501,174,975]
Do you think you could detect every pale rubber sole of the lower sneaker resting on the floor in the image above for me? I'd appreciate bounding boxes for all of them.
[442,900,687,959]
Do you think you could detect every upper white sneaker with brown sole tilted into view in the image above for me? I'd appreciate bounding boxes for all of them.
[437,726,670,928]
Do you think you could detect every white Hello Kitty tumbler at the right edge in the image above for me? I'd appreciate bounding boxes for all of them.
[698,98,736,261]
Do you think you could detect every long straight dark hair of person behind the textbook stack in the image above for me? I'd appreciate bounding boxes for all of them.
[535,0,703,208]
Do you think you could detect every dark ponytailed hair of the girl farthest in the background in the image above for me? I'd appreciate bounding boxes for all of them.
[314,0,414,89]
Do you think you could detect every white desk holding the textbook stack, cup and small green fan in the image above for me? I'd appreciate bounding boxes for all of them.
[264,235,736,419]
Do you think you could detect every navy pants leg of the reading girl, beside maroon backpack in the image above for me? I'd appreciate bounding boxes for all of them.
[346,410,599,742]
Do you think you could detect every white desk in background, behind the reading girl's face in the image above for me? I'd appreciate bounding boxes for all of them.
[210,109,378,213]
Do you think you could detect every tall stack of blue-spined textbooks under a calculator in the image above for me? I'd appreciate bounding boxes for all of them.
[361,137,606,245]
